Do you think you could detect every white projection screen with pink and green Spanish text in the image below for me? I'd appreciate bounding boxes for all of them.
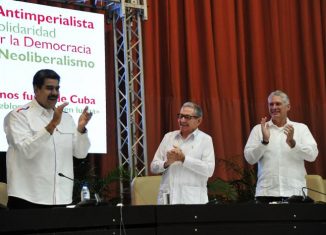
[0,0,107,153]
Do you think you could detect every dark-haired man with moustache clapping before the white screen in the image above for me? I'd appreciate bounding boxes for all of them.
[4,69,92,209]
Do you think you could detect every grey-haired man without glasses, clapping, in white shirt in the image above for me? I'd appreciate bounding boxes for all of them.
[244,90,318,203]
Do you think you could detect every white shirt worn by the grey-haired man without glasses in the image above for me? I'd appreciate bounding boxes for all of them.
[244,119,318,197]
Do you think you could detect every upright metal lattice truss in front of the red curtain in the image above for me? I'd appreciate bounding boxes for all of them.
[108,0,148,200]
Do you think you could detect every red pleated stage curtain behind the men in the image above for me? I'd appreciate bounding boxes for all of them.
[1,0,326,190]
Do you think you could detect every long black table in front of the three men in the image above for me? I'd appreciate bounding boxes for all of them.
[0,204,326,235]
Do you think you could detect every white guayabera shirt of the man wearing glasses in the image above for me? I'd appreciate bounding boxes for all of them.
[151,129,215,204]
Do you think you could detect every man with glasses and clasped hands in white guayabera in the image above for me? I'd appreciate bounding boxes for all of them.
[151,102,215,204]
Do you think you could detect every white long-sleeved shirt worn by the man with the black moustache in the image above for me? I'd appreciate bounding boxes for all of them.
[4,99,90,205]
